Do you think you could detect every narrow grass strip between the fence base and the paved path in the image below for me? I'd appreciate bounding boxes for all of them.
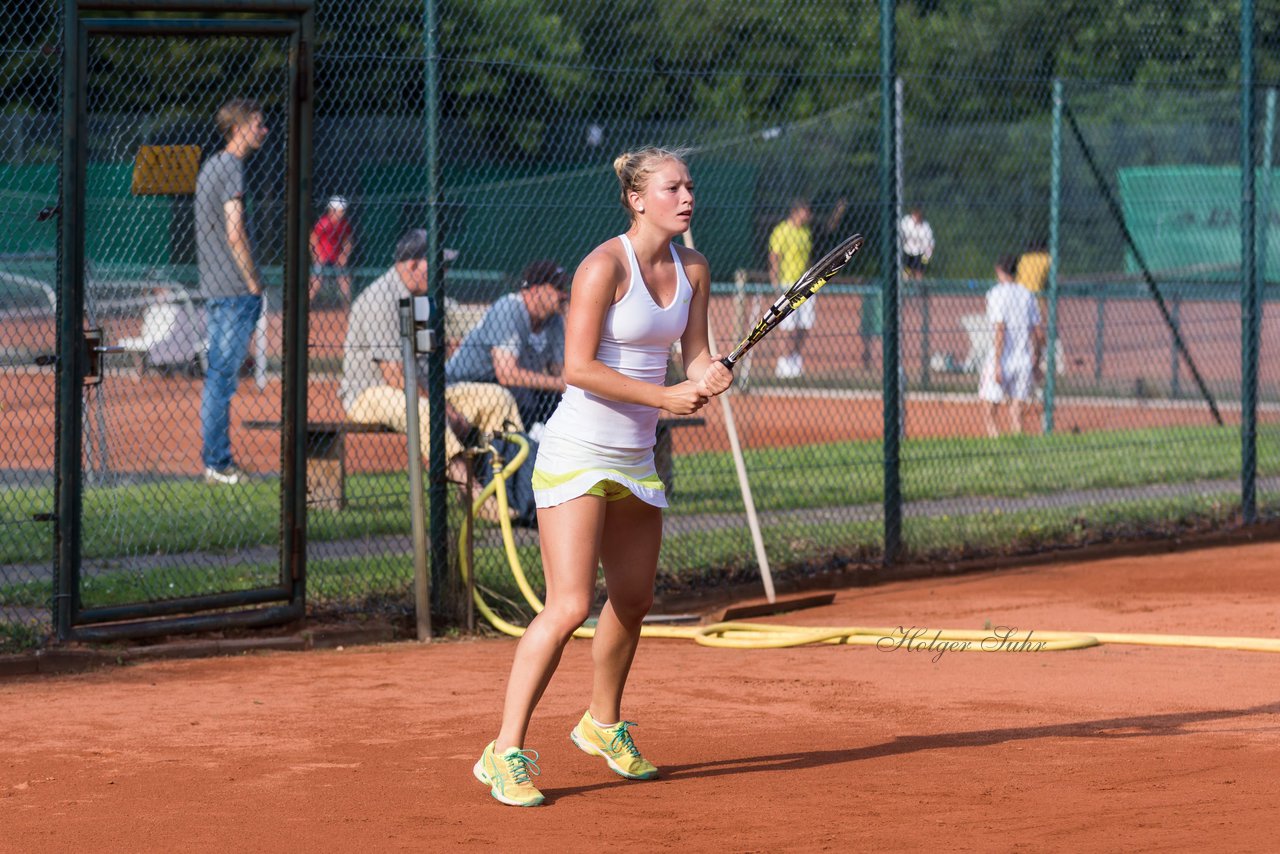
[0,493,1280,649]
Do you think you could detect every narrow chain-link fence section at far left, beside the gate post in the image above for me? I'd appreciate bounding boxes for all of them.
[0,4,61,652]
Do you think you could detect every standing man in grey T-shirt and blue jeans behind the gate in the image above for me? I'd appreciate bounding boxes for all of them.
[196,99,266,484]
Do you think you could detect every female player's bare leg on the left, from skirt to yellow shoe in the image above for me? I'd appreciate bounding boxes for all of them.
[495,495,605,753]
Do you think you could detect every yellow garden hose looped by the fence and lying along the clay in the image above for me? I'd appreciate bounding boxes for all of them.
[458,434,1280,656]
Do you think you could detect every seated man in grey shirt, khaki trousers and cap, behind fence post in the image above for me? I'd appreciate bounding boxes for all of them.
[338,229,525,514]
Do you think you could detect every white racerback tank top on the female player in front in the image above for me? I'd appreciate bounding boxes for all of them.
[547,234,694,449]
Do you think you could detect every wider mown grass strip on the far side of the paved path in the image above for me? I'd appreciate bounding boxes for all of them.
[0,426,1280,565]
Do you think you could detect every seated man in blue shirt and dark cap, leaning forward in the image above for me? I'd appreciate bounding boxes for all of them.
[444,260,568,439]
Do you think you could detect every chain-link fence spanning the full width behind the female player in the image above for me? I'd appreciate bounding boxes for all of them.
[0,0,1280,650]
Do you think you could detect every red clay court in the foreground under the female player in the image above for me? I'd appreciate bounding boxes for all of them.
[0,543,1280,851]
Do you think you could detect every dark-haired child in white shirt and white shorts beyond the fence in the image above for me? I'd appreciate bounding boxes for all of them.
[978,255,1044,437]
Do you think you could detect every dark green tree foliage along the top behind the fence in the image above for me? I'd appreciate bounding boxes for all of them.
[0,0,1280,147]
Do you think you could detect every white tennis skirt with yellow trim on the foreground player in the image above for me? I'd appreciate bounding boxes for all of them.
[534,426,667,507]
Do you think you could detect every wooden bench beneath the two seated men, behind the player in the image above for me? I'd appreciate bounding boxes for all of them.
[244,417,707,510]
